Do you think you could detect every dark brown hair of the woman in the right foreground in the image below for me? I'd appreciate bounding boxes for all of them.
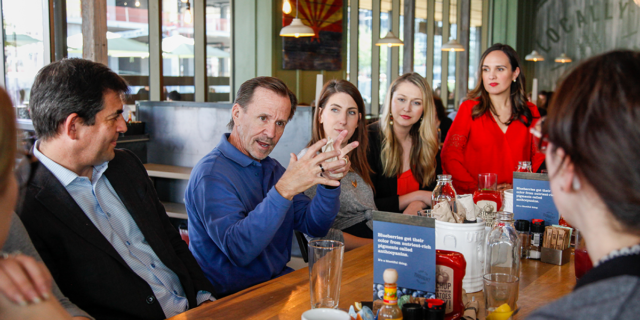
[542,50,640,235]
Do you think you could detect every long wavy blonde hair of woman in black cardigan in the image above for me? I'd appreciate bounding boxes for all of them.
[380,72,438,187]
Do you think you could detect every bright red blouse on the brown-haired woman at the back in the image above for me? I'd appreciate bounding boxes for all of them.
[442,100,544,194]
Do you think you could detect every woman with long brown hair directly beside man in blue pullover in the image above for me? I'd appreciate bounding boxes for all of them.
[299,80,376,250]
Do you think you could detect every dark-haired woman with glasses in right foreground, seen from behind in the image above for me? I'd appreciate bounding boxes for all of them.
[529,51,640,319]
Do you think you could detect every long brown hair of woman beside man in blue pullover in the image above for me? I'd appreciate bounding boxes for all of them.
[307,80,373,188]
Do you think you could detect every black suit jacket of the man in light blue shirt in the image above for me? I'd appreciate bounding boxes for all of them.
[18,149,214,320]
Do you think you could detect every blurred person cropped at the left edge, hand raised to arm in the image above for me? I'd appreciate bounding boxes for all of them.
[0,89,88,319]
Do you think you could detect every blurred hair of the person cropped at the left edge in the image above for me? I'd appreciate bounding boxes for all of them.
[0,88,17,194]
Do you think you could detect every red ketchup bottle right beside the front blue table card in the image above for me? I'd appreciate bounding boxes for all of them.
[436,250,467,320]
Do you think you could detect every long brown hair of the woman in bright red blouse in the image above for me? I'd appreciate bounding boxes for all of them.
[467,43,533,127]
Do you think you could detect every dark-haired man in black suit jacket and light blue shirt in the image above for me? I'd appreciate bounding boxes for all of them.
[18,59,215,320]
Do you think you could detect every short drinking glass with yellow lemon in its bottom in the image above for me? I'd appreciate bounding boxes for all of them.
[483,273,520,319]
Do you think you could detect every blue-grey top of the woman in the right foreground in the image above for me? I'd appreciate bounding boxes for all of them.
[527,275,640,320]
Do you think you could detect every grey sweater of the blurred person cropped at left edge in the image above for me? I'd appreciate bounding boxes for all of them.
[2,213,93,319]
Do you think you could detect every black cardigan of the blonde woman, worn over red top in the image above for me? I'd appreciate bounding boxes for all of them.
[367,122,442,212]
